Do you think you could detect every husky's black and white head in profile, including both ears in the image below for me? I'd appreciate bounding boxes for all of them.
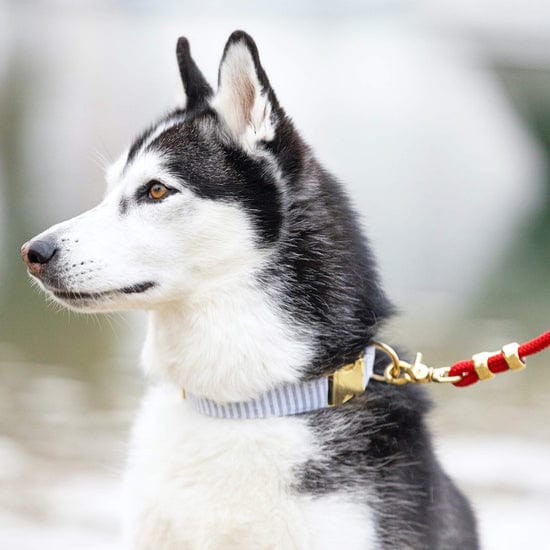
[22,31,297,311]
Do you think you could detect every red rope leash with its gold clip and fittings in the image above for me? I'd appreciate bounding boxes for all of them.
[371,331,550,388]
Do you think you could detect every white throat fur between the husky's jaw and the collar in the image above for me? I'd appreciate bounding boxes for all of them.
[142,283,312,403]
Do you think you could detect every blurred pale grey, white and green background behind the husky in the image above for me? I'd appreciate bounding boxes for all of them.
[0,0,550,550]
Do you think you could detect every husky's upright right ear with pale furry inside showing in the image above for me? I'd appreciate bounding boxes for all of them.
[212,31,282,150]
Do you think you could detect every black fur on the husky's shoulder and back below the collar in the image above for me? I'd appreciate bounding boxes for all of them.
[298,357,478,550]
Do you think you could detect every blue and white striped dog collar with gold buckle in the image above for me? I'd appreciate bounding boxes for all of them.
[183,346,375,419]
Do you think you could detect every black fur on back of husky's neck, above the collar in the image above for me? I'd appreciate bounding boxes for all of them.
[264,147,393,377]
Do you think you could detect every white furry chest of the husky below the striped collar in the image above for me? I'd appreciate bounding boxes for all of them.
[123,388,374,550]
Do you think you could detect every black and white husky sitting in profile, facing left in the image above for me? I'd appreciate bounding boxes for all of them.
[22,31,478,550]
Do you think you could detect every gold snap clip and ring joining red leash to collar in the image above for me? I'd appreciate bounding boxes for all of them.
[372,342,462,386]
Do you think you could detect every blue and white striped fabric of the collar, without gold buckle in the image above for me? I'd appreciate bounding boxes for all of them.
[186,346,375,419]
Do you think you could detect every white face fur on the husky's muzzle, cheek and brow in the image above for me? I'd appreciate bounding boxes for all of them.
[31,152,258,311]
